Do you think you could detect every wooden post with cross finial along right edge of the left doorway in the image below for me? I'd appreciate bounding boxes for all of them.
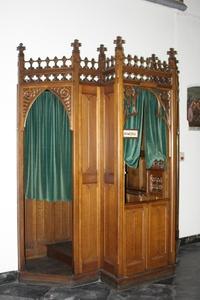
[71,40,81,274]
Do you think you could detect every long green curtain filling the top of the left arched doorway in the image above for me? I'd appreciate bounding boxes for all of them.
[24,91,72,201]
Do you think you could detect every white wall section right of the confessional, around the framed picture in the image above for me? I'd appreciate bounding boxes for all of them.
[176,0,200,236]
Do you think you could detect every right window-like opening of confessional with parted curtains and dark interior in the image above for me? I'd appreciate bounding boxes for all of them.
[124,88,168,202]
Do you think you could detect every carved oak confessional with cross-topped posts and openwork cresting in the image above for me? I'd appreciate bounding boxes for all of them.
[17,37,179,286]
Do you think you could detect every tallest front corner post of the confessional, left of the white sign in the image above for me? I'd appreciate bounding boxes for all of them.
[114,36,125,276]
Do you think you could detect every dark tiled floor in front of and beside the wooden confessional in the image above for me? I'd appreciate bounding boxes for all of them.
[0,243,200,300]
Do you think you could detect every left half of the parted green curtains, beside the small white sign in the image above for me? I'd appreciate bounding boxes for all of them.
[124,89,145,168]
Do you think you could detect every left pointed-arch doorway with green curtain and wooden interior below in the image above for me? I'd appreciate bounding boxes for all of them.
[24,90,73,275]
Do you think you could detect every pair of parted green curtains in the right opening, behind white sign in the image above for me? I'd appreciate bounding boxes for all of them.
[124,88,167,169]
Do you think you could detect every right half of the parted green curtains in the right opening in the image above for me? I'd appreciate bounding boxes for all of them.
[144,92,167,169]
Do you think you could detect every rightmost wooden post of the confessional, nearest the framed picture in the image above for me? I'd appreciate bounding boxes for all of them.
[167,48,179,264]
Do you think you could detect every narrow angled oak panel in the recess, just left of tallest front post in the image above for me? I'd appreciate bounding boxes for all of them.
[102,85,118,274]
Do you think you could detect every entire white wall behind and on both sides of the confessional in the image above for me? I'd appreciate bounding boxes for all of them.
[0,0,200,272]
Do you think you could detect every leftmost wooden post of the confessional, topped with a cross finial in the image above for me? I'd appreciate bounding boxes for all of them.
[17,43,26,271]
